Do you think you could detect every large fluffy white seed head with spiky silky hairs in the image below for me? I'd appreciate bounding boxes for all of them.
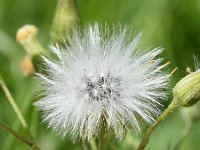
[35,24,167,141]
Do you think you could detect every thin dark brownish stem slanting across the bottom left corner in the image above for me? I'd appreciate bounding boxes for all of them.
[0,122,39,150]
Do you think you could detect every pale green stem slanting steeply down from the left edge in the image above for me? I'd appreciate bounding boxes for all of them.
[0,75,28,129]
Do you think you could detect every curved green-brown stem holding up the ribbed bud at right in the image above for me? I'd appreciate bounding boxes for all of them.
[138,100,178,150]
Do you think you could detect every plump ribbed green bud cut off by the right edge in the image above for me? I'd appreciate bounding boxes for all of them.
[173,70,200,107]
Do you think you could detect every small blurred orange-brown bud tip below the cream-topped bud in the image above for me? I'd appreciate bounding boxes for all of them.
[21,56,35,76]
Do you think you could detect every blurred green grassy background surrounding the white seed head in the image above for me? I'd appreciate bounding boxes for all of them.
[0,0,200,150]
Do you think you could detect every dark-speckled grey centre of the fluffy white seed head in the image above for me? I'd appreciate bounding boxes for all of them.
[80,74,121,101]
